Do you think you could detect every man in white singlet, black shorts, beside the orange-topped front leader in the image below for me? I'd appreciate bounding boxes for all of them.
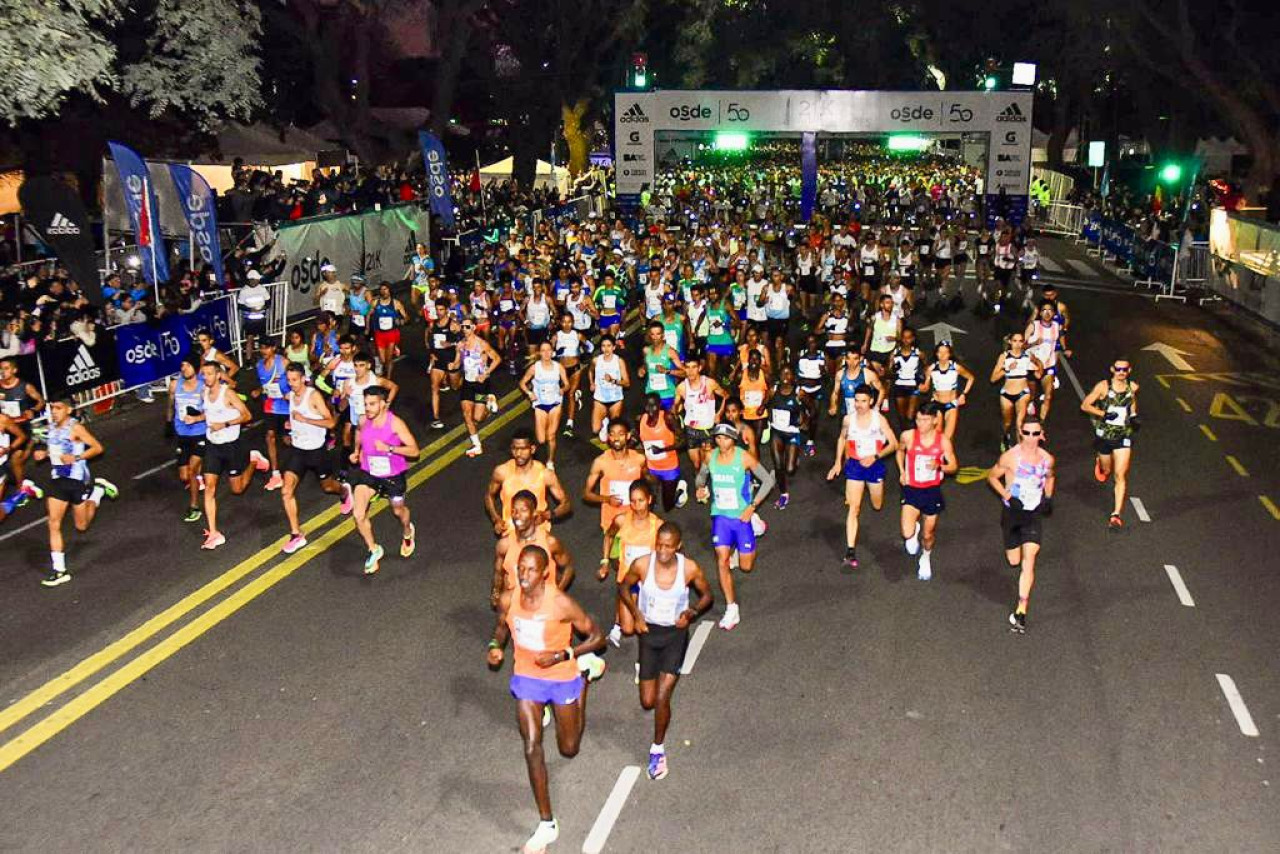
[618,522,713,780]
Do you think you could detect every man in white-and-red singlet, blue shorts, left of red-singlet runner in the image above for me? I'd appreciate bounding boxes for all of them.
[827,385,897,570]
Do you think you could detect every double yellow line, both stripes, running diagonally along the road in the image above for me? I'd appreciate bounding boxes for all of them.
[0,389,529,772]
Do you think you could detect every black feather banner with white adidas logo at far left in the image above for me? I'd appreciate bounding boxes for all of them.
[18,175,102,305]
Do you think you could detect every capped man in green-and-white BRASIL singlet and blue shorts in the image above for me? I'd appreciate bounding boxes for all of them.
[698,424,776,631]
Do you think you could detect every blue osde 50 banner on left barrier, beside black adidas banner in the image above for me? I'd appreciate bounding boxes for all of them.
[115,300,230,388]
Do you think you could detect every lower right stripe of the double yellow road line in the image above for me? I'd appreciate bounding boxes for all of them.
[0,401,529,772]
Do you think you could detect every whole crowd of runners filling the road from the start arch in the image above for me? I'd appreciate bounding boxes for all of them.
[0,151,1138,851]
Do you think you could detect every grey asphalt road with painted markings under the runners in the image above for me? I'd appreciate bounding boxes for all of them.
[0,235,1280,853]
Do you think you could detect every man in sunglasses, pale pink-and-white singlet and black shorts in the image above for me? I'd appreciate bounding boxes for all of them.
[987,415,1056,635]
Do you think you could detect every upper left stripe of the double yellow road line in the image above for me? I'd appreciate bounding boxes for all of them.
[0,389,524,732]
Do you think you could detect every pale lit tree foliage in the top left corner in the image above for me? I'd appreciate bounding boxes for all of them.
[0,0,262,127]
